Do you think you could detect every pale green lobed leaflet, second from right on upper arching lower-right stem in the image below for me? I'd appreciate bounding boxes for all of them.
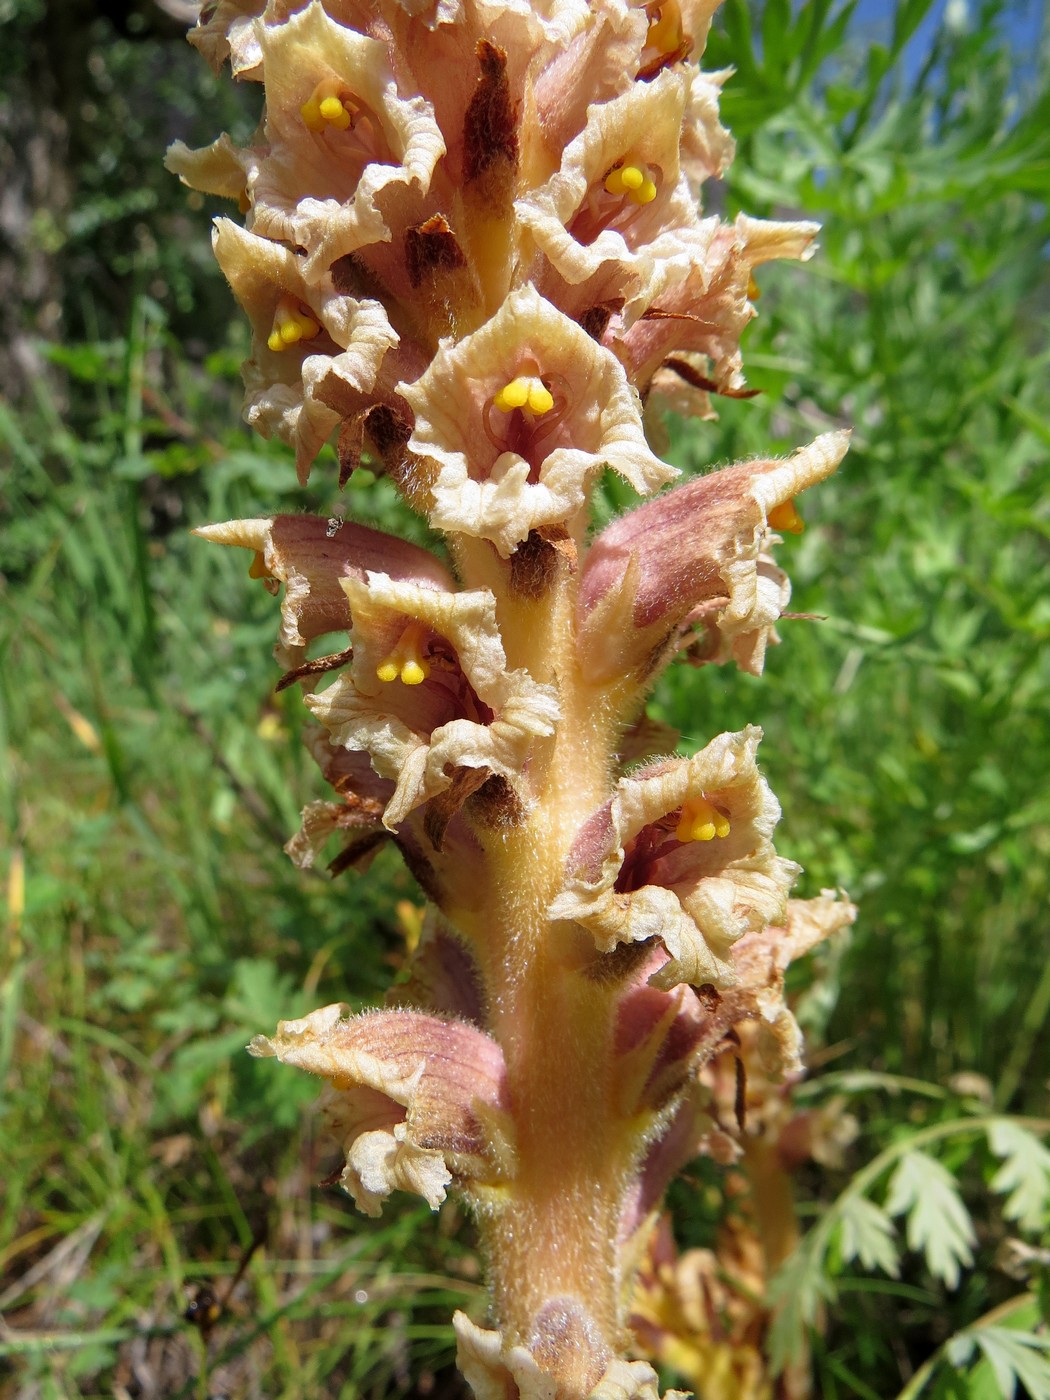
[886,1152,974,1288]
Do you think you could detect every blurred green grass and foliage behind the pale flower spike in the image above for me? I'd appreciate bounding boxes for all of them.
[0,0,1050,1400]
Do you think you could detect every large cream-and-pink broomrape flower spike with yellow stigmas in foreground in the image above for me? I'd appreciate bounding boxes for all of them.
[168,0,853,1400]
